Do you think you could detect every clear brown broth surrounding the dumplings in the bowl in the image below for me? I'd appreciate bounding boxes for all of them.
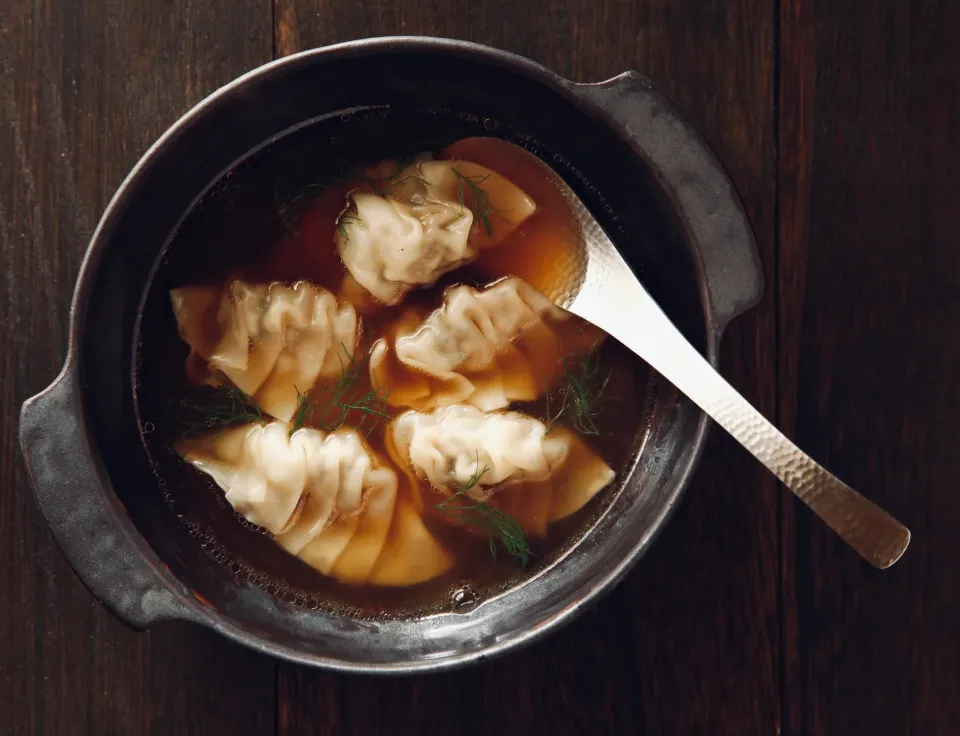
[137,111,651,616]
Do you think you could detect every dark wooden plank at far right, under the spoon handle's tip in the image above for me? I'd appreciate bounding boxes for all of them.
[778,0,960,734]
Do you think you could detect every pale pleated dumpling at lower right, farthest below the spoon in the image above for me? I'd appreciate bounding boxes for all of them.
[389,405,614,536]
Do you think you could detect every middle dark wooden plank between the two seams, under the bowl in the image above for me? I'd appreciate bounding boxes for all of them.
[276,0,779,735]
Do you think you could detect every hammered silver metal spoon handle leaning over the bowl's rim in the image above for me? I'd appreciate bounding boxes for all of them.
[501,141,910,569]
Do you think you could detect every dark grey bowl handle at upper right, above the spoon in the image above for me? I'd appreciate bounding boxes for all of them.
[569,71,764,337]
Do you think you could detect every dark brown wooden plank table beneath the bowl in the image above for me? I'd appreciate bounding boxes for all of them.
[0,0,960,736]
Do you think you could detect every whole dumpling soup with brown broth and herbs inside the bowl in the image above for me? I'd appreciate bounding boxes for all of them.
[137,116,649,616]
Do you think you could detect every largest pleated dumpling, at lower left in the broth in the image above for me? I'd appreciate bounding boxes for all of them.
[177,421,452,585]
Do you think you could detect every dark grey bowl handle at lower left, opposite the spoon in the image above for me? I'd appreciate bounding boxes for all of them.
[20,358,202,630]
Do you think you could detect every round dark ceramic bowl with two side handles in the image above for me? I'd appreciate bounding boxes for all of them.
[20,38,762,672]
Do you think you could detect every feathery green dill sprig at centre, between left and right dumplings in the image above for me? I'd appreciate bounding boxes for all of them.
[291,345,390,436]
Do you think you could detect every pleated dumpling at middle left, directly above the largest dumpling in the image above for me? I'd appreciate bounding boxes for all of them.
[170,280,357,421]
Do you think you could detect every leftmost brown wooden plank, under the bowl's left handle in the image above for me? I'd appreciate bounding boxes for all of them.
[0,0,275,734]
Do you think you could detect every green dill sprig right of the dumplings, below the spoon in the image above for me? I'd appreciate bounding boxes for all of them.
[546,339,610,435]
